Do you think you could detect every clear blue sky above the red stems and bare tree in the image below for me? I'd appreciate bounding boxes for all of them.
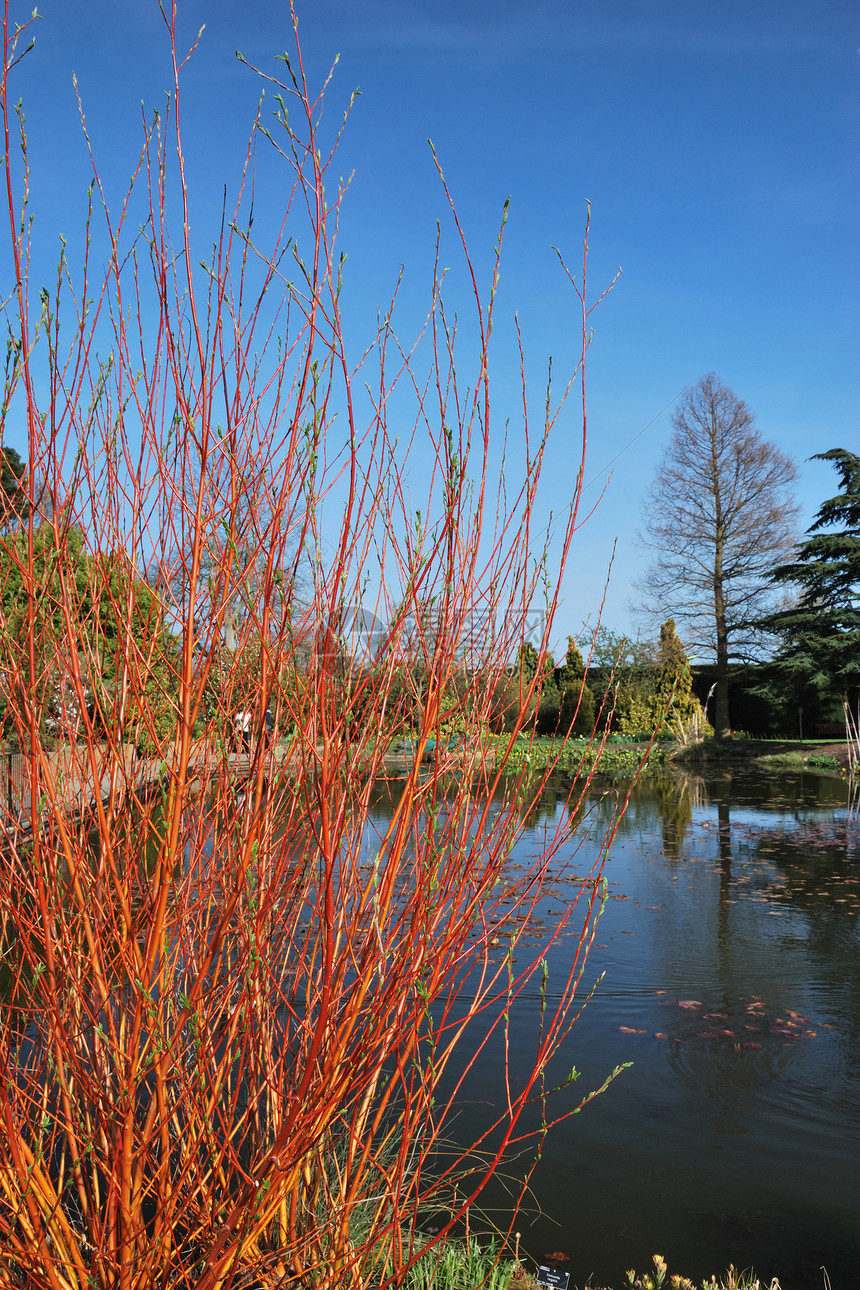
[6,0,860,640]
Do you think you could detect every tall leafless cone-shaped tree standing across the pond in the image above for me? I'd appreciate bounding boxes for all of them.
[640,373,798,738]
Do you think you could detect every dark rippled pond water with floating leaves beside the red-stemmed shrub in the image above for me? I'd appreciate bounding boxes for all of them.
[373,774,860,1290]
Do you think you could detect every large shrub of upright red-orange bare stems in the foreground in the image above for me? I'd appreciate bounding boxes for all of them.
[0,3,631,1290]
